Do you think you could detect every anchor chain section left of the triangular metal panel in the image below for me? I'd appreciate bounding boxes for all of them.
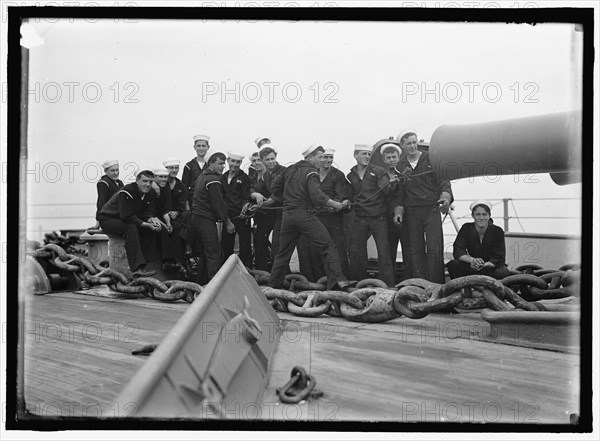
[27,243,202,303]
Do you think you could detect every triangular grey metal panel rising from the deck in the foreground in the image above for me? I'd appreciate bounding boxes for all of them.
[117,255,281,419]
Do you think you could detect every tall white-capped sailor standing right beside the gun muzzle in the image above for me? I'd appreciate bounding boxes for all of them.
[397,129,454,283]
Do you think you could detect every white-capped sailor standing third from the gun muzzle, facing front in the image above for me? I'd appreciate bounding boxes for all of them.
[348,144,402,286]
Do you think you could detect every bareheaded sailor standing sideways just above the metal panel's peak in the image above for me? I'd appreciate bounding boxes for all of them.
[191,152,235,284]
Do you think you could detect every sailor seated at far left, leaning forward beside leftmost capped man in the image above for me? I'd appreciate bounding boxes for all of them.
[98,170,162,276]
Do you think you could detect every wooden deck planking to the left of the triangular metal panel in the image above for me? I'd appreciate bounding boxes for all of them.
[24,293,189,416]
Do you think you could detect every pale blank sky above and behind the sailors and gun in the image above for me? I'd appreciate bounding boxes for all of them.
[23,19,582,234]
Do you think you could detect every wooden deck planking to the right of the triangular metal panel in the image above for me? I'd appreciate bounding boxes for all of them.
[265,316,579,424]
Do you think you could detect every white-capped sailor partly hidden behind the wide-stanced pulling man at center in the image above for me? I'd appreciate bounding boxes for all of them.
[298,149,352,282]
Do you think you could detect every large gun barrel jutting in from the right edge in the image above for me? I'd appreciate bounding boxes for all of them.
[429,111,582,185]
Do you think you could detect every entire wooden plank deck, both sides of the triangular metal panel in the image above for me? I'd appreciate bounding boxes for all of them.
[25,293,580,424]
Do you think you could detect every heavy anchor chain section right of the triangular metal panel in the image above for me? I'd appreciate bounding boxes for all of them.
[249,265,580,323]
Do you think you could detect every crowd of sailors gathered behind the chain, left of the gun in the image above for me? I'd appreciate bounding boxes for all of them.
[96,129,510,289]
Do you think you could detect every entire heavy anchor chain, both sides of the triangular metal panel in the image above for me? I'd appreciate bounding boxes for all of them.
[28,243,581,323]
